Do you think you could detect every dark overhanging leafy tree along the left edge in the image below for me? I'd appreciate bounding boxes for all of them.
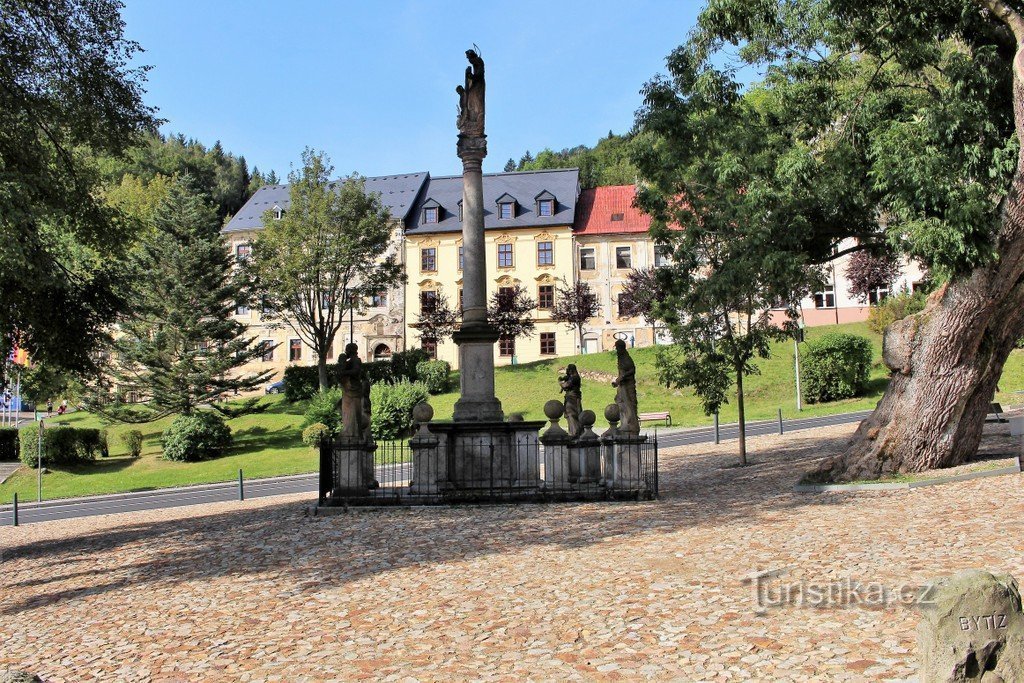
[0,0,158,379]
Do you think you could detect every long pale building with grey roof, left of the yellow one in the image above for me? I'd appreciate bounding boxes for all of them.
[222,173,429,379]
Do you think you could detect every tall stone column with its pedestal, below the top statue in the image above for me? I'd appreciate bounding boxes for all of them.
[452,114,505,422]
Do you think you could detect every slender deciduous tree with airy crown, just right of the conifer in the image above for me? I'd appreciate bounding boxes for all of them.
[247,148,406,390]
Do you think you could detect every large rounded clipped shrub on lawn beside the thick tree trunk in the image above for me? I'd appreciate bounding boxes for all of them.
[801,332,871,403]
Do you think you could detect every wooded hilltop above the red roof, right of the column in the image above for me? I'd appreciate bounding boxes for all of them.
[505,130,637,187]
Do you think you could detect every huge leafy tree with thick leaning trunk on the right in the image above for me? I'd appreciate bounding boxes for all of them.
[634,0,1024,480]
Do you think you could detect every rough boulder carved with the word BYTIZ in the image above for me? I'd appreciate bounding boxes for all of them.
[918,570,1024,683]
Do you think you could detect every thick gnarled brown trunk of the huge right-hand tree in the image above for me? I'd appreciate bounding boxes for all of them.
[808,42,1024,482]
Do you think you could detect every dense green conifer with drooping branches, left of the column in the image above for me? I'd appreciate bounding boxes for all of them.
[99,177,270,422]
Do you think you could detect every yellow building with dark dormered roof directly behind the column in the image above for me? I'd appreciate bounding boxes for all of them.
[404,169,580,368]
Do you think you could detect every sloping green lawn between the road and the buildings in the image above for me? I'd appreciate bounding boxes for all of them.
[0,323,1024,503]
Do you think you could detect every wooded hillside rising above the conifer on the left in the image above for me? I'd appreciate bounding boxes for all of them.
[98,133,278,219]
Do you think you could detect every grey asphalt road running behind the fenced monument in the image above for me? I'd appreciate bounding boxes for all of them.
[0,411,870,525]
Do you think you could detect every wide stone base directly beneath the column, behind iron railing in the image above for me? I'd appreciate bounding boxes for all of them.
[430,422,544,492]
